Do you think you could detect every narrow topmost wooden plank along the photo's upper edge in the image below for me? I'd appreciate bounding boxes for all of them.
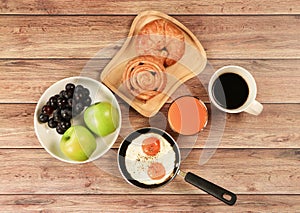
[0,0,300,15]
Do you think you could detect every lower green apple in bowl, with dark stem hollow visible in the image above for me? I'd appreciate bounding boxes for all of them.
[60,126,97,161]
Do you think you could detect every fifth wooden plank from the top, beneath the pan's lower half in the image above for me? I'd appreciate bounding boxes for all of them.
[0,149,300,196]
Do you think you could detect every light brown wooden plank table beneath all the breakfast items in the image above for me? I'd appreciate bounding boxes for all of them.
[0,0,300,212]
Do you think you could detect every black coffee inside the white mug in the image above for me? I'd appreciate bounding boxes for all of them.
[212,73,249,109]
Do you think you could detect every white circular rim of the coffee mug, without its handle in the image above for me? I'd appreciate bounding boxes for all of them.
[208,65,257,113]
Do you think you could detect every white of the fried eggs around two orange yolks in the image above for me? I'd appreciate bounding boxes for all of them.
[125,133,176,185]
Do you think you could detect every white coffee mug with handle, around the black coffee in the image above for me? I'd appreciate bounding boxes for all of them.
[208,65,263,115]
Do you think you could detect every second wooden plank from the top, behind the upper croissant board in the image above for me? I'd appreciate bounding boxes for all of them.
[0,16,300,59]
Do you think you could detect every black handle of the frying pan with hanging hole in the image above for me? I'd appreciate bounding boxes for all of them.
[184,172,236,206]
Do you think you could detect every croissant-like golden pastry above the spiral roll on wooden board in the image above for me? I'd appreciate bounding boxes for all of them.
[136,19,185,67]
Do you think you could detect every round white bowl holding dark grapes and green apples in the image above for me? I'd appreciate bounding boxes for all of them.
[34,77,121,164]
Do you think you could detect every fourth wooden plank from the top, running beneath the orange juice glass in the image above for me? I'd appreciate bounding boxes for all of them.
[0,104,300,148]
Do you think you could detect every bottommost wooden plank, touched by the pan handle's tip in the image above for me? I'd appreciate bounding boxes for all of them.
[0,195,300,213]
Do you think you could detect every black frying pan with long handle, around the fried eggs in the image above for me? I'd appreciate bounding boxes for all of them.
[118,127,236,205]
